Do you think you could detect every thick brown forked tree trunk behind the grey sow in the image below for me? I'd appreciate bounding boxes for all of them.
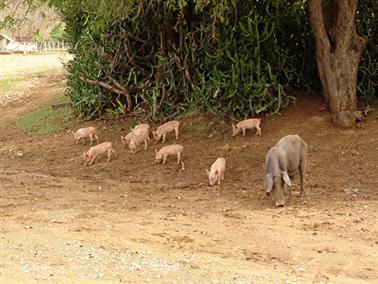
[309,0,367,113]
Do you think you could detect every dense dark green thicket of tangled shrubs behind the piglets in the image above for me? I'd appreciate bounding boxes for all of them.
[35,0,378,119]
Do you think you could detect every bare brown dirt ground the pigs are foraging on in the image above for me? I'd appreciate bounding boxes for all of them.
[0,68,378,283]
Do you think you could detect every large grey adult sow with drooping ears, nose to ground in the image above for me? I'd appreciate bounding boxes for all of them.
[264,135,308,206]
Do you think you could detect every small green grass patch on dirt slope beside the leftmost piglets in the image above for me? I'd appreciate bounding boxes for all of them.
[16,106,78,134]
